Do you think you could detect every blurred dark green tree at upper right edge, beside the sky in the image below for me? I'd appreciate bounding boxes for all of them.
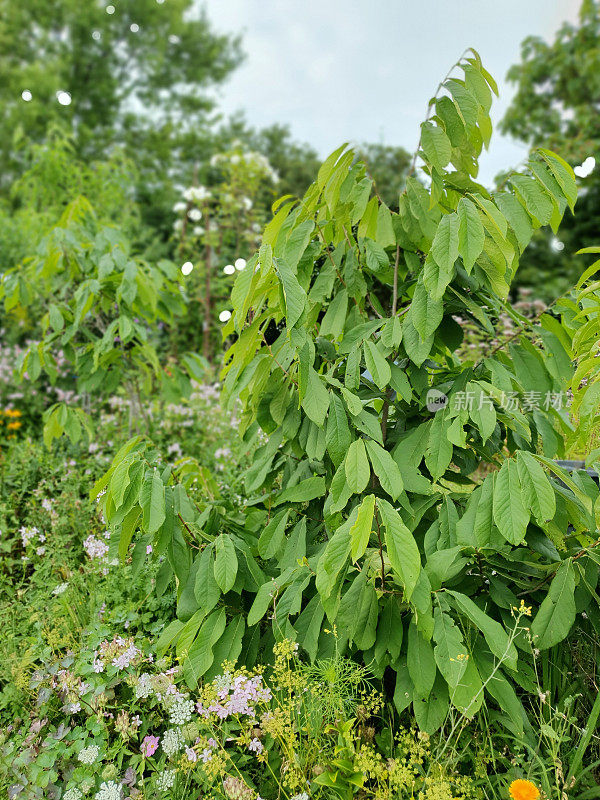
[500,0,600,297]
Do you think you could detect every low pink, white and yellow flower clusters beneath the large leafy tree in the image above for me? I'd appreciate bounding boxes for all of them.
[0,635,475,800]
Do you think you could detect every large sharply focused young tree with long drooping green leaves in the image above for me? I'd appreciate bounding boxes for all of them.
[95,53,597,731]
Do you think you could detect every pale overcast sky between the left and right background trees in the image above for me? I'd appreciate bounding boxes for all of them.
[203,0,579,183]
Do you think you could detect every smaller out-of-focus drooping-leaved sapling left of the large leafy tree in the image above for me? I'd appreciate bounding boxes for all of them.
[0,196,190,445]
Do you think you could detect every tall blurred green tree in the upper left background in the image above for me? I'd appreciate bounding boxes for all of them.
[0,0,241,234]
